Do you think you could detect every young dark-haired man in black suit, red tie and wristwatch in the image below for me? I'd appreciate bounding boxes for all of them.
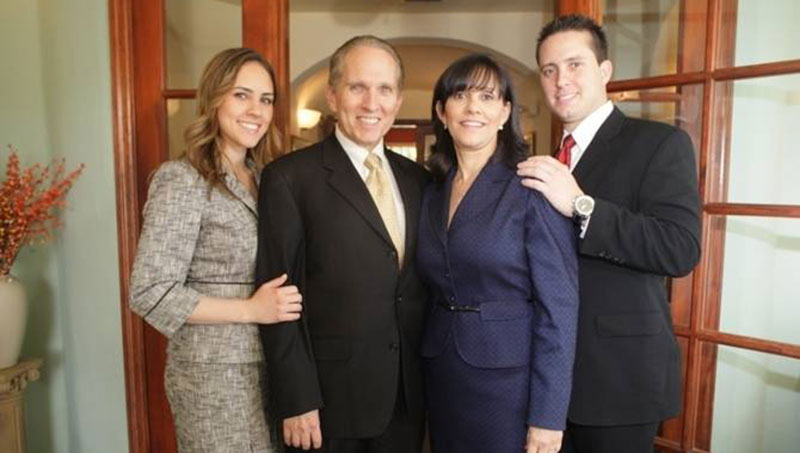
[519,15,700,453]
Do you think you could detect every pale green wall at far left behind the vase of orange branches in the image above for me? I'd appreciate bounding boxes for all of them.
[0,0,128,453]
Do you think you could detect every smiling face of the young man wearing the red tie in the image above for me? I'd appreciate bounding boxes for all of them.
[539,30,612,131]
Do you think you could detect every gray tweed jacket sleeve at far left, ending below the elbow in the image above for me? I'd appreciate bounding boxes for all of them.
[130,162,207,337]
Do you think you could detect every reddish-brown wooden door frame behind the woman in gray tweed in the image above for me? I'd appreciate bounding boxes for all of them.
[108,0,289,453]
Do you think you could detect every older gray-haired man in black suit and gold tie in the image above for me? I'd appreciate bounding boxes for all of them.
[256,36,427,453]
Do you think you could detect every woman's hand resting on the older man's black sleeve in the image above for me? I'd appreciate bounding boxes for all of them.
[247,274,303,324]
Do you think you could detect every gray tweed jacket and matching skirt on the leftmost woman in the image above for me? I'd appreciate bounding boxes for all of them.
[130,161,273,453]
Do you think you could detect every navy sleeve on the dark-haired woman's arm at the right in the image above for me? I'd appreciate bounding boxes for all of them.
[525,191,578,430]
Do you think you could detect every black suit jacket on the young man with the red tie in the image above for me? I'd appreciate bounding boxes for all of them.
[569,108,700,425]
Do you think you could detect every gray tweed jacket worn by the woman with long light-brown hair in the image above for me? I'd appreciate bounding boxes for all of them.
[130,160,263,363]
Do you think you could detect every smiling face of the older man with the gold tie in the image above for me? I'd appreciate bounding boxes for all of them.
[326,46,402,150]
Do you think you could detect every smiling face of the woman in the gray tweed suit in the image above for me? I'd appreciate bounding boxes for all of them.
[217,61,275,153]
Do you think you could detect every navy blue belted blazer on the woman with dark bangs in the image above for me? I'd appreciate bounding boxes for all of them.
[417,161,578,435]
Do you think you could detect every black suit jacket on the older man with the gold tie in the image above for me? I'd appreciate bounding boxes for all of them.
[256,135,428,438]
